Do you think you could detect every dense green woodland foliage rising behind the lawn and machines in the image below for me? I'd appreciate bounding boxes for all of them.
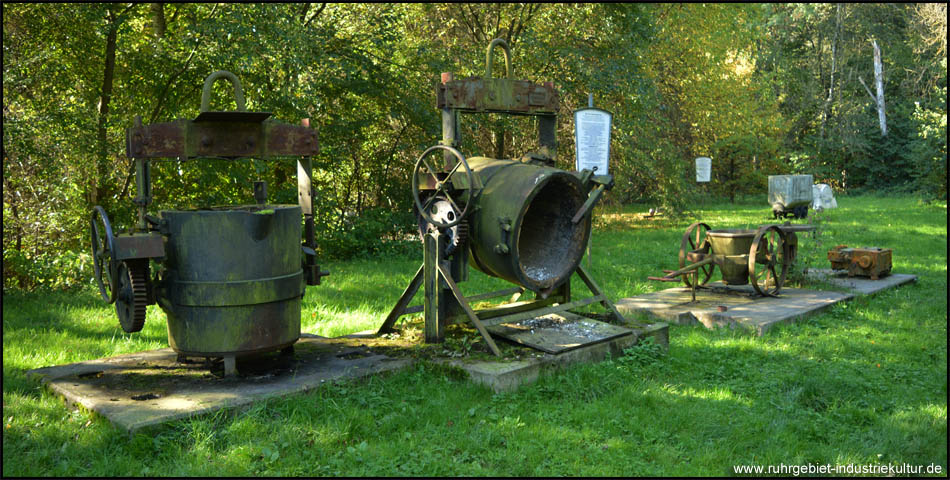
[2,3,947,288]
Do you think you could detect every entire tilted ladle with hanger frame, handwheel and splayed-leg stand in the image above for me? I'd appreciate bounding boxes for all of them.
[378,39,631,355]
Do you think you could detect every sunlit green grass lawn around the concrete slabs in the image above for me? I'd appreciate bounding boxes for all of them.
[3,196,947,476]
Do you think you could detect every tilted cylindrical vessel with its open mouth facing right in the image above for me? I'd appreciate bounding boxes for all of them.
[468,157,591,291]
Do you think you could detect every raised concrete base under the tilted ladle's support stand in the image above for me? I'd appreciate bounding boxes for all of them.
[436,323,670,392]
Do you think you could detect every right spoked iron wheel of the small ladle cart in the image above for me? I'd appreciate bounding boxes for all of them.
[749,225,790,297]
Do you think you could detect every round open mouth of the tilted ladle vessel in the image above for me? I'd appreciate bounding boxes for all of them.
[518,174,591,289]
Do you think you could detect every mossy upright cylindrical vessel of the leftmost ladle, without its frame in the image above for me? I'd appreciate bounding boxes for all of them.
[157,205,304,356]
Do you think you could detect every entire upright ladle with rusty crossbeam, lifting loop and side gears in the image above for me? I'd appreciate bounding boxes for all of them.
[90,71,328,375]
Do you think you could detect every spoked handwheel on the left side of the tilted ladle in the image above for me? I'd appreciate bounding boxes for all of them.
[412,145,475,229]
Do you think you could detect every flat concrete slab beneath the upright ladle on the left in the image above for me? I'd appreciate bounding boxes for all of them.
[27,334,412,433]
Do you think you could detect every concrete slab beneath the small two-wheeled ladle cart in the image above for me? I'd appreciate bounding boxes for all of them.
[616,282,854,335]
